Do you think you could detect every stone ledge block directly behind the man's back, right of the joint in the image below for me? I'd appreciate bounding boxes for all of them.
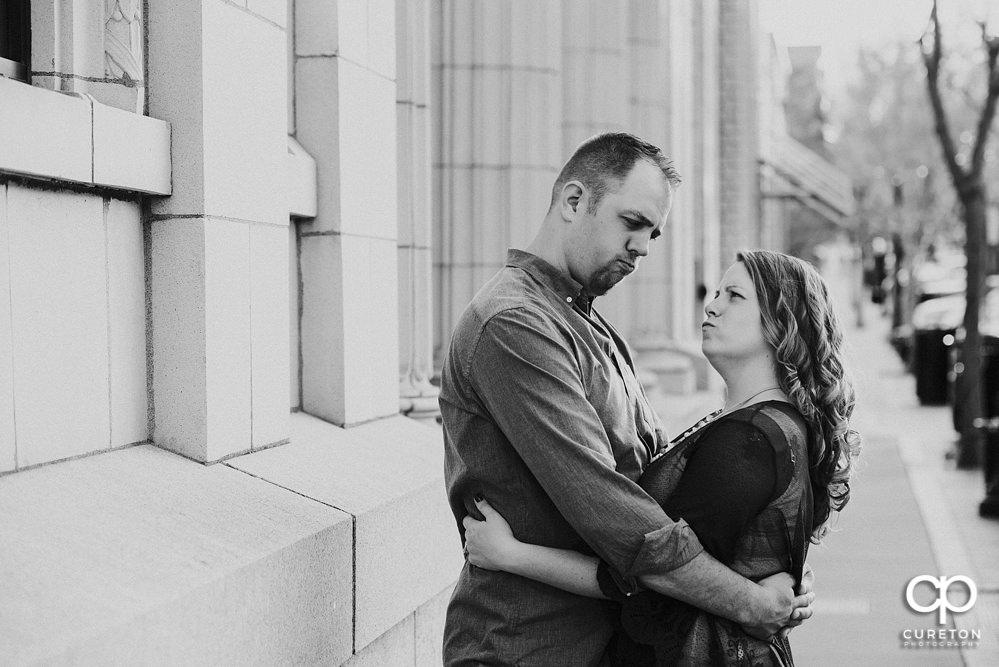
[228,413,463,651]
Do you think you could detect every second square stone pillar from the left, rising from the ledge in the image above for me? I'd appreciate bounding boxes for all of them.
[295,0,399,426]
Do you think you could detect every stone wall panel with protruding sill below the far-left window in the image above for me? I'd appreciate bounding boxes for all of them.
[0,74,171,473]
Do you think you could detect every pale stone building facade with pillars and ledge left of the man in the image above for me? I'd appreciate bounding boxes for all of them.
[0,0,462,666]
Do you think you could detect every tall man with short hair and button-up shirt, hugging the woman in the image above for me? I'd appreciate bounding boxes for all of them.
[440,133,811,667]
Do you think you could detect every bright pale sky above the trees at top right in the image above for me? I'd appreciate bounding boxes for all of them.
[760,0,999,94]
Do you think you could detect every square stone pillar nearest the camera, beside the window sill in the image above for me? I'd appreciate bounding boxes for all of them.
[146,0,289,461]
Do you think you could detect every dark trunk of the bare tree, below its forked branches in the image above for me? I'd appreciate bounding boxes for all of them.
[956,185,989,468]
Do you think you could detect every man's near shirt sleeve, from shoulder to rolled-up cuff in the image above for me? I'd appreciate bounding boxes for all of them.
[465,308,703,578]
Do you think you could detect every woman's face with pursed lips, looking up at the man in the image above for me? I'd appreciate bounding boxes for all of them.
[701,262,771,366]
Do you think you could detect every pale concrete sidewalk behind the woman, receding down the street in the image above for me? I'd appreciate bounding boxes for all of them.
[657,302,999,667]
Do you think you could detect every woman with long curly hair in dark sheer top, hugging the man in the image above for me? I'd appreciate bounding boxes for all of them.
[464,250,860,665]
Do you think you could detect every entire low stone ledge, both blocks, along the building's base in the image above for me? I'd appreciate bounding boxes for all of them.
[0,415,461,665]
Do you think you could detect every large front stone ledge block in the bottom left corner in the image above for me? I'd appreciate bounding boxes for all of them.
[0,445,352,665]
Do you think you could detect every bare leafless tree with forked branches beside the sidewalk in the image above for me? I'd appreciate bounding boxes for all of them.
[920,0,999,467]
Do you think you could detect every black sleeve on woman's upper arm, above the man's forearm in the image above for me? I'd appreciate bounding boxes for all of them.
[663,419,777,563]
